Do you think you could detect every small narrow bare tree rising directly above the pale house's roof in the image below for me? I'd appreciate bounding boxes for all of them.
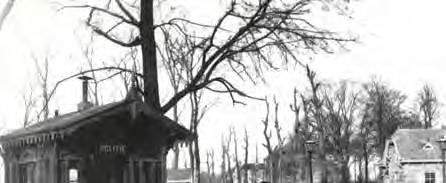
[417,84,439,129]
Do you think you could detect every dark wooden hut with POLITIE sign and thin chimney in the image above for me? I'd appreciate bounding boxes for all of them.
[0,78,193,183]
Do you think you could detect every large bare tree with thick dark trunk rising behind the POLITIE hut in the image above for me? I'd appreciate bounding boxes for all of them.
[64,0,353,112]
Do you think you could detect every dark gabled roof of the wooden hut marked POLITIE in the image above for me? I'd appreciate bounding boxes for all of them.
[0,92,192,146]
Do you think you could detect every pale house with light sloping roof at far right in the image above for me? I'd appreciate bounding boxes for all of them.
[382,129,446,183]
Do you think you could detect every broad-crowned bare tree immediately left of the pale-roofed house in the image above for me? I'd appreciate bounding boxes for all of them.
[359,79,421,182]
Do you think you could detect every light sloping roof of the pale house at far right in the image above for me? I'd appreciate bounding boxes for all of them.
[391,129,446,161]
